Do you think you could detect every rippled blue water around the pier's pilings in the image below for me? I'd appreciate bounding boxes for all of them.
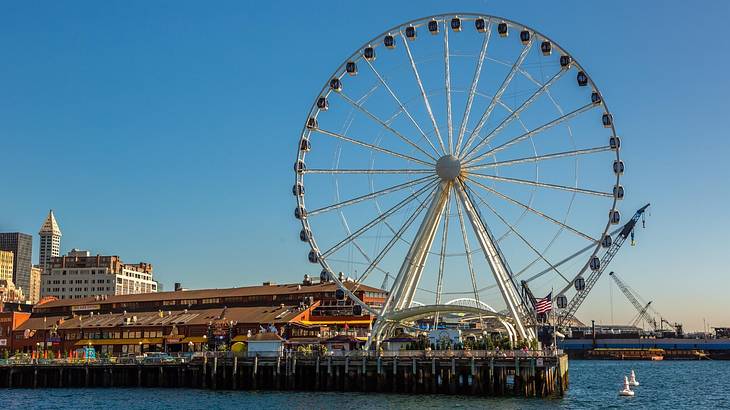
[0,360,730,410]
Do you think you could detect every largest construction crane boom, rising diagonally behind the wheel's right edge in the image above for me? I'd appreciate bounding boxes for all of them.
[557,204,650,327]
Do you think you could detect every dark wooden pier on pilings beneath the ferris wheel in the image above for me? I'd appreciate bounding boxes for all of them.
[0,351,568,397]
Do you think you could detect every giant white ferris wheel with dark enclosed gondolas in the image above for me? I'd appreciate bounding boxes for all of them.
[292,13,624,340]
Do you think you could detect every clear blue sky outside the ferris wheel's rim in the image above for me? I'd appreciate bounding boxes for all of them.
[0,1,730,329]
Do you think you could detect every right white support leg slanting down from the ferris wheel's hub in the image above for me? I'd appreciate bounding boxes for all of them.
[456,183,535,340]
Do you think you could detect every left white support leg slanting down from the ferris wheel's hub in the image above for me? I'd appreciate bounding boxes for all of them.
[372,181,452,337]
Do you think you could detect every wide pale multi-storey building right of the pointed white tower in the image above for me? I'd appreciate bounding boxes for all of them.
[41,249,158,299]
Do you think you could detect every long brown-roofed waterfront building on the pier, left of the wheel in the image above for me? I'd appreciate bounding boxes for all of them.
[15,274,386,355]
